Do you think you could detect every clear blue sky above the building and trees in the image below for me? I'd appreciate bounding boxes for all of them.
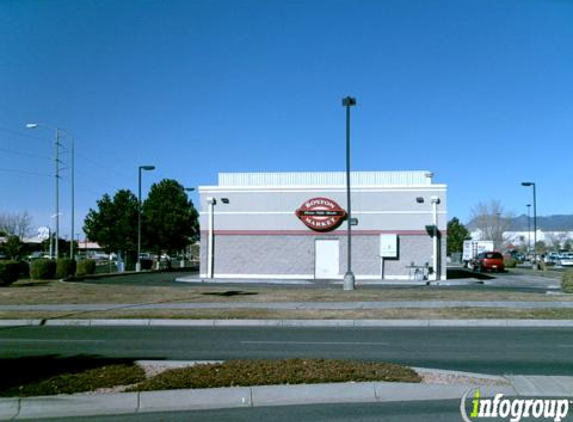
[0,0,573,237]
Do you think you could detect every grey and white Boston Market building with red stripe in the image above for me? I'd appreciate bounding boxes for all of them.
[199,171,447,280]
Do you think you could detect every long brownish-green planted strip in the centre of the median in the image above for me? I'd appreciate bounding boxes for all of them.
[128,359,421,391]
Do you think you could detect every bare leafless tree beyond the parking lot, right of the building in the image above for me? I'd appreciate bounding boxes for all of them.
[471,199,514,249]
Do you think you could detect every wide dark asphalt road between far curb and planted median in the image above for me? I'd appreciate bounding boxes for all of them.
[0,327,573,375]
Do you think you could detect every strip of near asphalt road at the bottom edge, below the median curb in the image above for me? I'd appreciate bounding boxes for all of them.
[19,400,510,422]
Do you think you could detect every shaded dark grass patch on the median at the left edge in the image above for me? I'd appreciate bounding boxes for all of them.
[0,364,145,397]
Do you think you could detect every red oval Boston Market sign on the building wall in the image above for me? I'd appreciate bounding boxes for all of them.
[296,198,346,232]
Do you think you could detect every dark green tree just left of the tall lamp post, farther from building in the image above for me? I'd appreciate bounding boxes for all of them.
[84,189,138,253]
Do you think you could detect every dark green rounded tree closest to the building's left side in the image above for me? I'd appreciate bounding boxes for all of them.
[143,179,199,253]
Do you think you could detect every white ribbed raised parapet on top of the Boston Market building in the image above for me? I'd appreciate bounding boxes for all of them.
[218,171,433,187]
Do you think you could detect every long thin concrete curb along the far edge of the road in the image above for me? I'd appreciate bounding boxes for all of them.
[0,319,573,328]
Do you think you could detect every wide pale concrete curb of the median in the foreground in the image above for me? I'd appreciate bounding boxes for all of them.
[0,382,517,420]
